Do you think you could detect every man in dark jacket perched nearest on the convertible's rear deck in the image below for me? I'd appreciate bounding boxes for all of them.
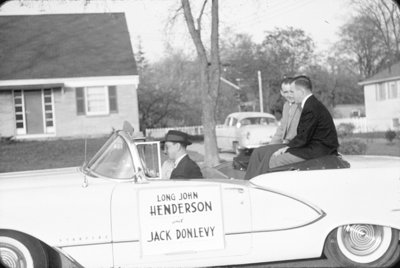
[269,75,339,168]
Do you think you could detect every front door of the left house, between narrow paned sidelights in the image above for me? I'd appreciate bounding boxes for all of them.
[24,90,44,134]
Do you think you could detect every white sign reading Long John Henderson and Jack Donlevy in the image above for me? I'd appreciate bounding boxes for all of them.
[138,185,224,255]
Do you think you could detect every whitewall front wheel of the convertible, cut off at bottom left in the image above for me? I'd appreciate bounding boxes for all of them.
[0,231,48,268]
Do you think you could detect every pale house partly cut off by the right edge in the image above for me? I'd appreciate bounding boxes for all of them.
[359,62,400,131]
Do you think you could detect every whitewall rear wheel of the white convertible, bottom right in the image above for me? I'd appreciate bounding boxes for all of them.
[324,224,400,267]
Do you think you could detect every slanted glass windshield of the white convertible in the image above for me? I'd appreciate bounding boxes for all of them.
[88,135,135,179]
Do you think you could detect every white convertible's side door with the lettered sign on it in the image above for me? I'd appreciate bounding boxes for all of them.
[111,180,251,267]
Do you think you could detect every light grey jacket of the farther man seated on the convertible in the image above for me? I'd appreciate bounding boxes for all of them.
[270,101,301,144]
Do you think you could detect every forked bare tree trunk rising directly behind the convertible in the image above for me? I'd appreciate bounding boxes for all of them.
[181,0,220,167]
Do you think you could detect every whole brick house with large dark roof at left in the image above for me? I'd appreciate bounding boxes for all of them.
[0,13,139,139]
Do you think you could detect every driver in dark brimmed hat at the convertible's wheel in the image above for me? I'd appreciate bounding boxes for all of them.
[164,130,203,179]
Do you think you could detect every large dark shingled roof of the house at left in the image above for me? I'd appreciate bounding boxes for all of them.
[0,13,137,80]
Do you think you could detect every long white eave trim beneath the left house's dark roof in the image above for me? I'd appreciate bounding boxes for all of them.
[0,75,139,90]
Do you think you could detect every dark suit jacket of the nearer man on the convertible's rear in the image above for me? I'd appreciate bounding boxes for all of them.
[287,95,339,159]
